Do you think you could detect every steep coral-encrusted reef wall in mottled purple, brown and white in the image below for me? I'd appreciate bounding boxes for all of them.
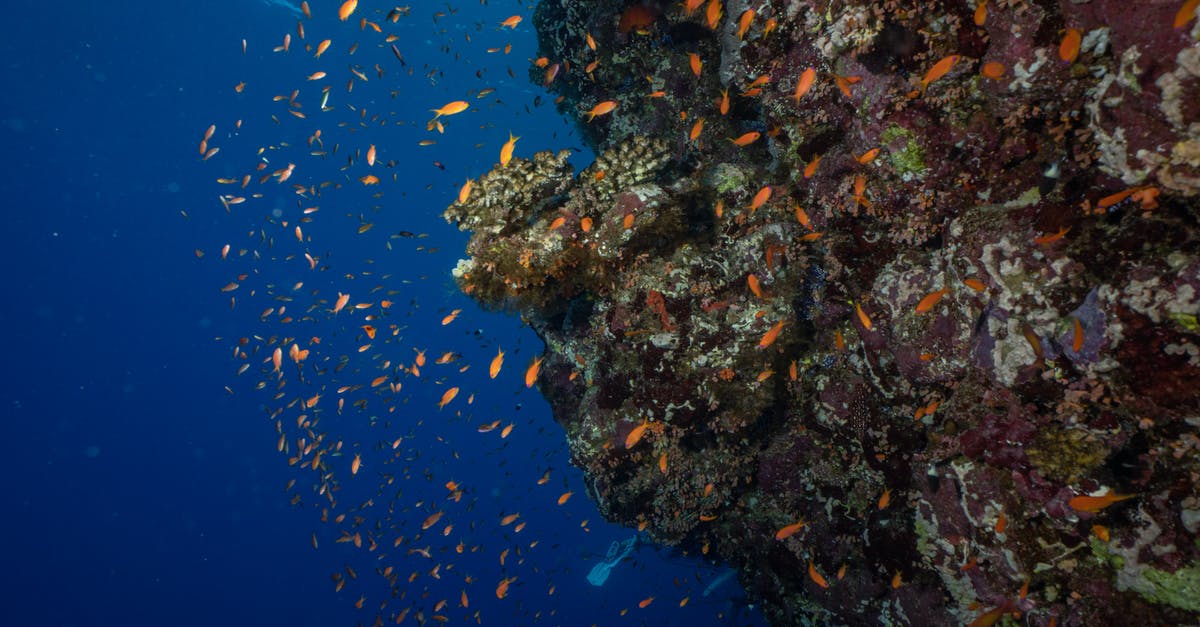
[445,0,1200,626]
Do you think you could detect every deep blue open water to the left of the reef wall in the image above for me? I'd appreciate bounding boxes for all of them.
[0,0,761,626]
